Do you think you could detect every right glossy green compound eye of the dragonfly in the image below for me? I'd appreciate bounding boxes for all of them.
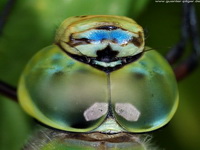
[110,51,178,133]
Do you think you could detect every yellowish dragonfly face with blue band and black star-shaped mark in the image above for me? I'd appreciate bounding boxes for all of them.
[55,15,144,69]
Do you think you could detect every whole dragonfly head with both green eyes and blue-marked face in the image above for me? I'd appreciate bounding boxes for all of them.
[18,16,178,133]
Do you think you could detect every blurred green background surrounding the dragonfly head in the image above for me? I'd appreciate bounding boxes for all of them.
[0,0,200,150]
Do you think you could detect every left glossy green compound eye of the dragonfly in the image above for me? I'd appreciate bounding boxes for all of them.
[18,46,108,132]
